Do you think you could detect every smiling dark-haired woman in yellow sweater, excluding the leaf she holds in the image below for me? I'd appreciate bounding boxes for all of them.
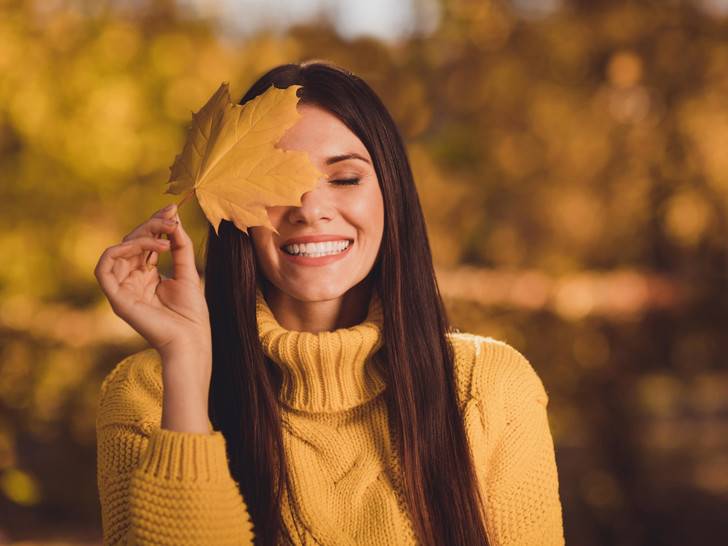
[95,62,563,545]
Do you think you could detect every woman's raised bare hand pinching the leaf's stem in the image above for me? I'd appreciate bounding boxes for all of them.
[94,204,212,360]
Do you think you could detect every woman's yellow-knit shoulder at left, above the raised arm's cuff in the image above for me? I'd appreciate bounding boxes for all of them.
[96,348,162,428]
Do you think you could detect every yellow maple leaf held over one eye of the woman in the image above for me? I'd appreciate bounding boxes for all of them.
[165,83,326,234]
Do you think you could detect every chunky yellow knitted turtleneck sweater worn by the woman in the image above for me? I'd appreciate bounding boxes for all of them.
[96,290,564,546]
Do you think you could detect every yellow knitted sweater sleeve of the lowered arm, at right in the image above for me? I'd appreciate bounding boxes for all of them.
[480,343,565,546]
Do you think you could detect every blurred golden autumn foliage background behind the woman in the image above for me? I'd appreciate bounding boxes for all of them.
[0,0,728,546]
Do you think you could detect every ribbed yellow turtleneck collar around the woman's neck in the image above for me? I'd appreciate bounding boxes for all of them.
[256,287,386,413]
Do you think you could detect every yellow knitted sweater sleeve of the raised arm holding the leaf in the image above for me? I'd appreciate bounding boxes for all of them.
[96,351,253,546]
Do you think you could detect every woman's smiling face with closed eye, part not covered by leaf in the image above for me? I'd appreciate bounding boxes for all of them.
[248,104,384,301]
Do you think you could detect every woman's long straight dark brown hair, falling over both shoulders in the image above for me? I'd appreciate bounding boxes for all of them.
[205,61,487,546]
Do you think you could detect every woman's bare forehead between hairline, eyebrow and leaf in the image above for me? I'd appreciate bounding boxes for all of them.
[278,104,371,159]
